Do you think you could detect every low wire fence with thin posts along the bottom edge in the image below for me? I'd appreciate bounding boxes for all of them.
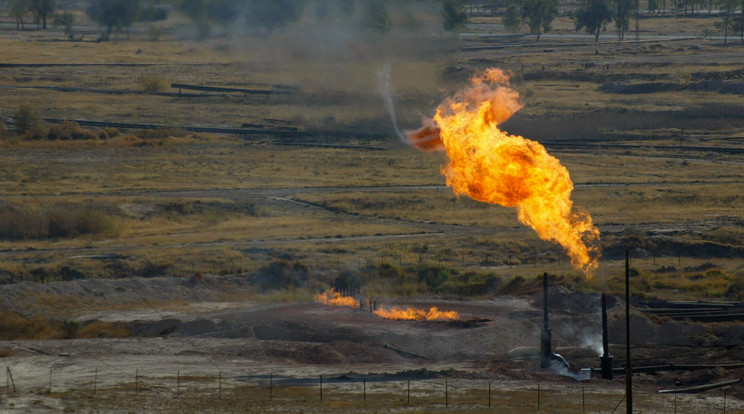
[5,366,744,414]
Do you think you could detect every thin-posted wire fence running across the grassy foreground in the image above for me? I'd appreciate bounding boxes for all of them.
[0,364,744,414]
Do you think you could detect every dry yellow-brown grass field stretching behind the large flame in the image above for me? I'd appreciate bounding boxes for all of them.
[0,4,744,413]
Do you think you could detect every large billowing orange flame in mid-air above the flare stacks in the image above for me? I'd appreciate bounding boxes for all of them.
[408,68,600,277]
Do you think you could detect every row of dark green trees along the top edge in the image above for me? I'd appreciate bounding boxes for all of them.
[5,0,744,44]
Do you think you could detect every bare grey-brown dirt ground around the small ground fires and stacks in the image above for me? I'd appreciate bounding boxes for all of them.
[0,276,744,413]
